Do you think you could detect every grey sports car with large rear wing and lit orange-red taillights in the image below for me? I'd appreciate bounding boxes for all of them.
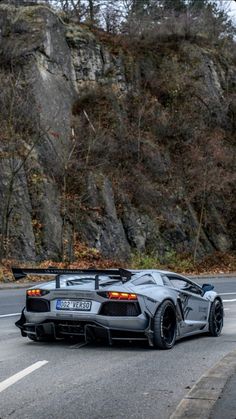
[13,268,224,349]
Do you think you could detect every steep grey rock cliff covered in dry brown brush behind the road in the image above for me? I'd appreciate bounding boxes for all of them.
[0,4,236,260]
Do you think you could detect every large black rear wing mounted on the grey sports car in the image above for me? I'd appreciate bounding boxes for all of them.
[12,267,133,289]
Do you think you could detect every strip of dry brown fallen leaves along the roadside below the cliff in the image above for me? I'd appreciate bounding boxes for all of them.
[0,251,236,284]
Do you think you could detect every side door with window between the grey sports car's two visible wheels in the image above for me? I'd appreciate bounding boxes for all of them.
[168,275,210,334]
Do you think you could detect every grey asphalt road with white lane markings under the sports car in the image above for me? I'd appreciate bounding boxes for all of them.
[0,277,236,419]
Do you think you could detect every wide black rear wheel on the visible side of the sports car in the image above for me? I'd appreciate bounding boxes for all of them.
[153,300,177,349]
